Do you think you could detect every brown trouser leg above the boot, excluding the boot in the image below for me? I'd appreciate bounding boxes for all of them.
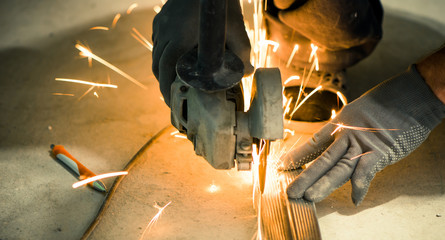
[265,0,383,72]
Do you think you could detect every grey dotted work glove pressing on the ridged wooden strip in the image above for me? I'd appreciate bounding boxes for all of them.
[283,65,445,205]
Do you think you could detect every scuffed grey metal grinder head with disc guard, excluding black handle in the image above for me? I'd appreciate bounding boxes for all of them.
[171,68,283,170]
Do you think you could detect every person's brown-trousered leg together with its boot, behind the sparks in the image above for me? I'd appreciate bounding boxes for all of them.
[264,0,383,122]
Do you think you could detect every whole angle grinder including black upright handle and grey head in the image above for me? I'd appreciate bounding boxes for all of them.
[170,0,283,170]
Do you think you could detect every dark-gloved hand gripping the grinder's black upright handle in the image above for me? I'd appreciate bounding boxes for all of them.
[152,0,253,105]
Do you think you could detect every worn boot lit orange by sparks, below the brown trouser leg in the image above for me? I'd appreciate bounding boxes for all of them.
[264,6,350,122]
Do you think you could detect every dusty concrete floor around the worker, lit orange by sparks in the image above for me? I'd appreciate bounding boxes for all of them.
[0,0,445,240]
